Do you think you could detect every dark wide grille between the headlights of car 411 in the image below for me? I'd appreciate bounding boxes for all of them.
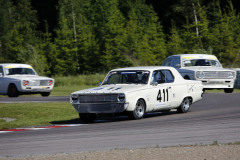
[79,94,118,103]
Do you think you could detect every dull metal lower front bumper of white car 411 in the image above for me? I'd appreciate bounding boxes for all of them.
[72,102,128,114]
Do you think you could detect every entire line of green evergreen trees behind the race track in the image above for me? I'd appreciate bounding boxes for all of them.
[0,0,240,76]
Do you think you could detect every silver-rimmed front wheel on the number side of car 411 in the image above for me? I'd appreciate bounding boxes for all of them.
[128,99,146,119]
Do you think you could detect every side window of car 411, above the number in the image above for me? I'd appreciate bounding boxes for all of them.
[152,70,174,84]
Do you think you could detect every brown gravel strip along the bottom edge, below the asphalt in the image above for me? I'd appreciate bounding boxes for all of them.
[0,144,240,160]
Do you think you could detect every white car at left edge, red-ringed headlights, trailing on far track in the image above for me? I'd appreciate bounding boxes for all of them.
[0,63,54,97]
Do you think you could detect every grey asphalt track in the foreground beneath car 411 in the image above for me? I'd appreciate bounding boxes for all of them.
[0,93,240,157]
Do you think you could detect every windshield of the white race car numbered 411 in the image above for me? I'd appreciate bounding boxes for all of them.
[102,70,150,85]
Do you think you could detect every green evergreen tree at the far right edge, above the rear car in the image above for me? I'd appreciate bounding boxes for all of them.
[212,2,240,67]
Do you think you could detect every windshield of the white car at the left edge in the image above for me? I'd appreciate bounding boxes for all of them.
[5,68,36,75]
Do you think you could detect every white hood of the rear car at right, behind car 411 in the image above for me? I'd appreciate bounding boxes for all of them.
[180,66,232,71]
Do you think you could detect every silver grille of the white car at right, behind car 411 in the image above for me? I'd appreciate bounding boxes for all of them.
[203,71,232,79]
